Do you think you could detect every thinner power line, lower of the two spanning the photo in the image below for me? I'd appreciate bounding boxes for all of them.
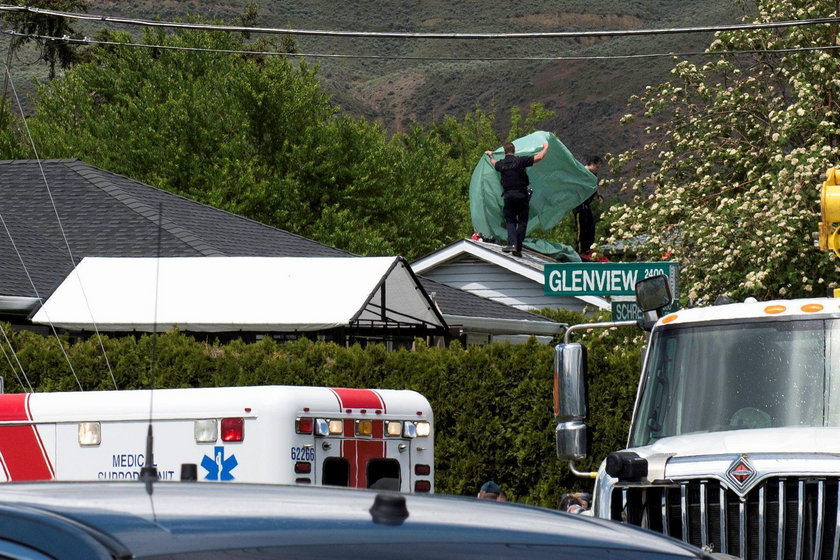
[6,31,840,62]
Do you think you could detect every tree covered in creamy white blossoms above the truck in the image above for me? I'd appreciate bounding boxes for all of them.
[605,0,840,304]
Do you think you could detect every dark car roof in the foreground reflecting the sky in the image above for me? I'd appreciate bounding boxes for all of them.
[0,482,708,559]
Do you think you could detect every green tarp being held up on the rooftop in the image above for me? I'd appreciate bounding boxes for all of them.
[470,130,598,260]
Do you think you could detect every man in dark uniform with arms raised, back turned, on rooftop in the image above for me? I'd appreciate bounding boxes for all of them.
[484,142,548,257]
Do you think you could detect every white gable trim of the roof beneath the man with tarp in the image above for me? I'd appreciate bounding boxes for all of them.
[411,239,611,309]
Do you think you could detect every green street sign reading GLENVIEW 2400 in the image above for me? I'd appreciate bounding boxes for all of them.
[543,261,679,299]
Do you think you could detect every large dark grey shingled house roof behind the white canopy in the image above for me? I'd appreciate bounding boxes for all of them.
[0,159,354,297]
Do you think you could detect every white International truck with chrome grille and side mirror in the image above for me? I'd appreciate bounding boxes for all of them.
[555,277,840,560]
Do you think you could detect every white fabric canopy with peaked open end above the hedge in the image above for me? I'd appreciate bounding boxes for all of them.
[32,257,446,332]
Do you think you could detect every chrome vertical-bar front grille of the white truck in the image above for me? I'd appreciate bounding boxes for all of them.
[611,477,840,560]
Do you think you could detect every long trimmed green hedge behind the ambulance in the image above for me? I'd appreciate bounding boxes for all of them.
[0,314,640,507]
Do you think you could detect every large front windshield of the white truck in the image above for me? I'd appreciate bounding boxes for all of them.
[630,319,840,447]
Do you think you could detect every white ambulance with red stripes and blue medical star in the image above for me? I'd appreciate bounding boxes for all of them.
[0,386,434,492]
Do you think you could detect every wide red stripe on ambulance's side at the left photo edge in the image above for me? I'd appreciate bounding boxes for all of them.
[0,393,55,481]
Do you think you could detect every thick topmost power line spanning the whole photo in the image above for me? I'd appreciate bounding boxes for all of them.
[0,5,840,39]
